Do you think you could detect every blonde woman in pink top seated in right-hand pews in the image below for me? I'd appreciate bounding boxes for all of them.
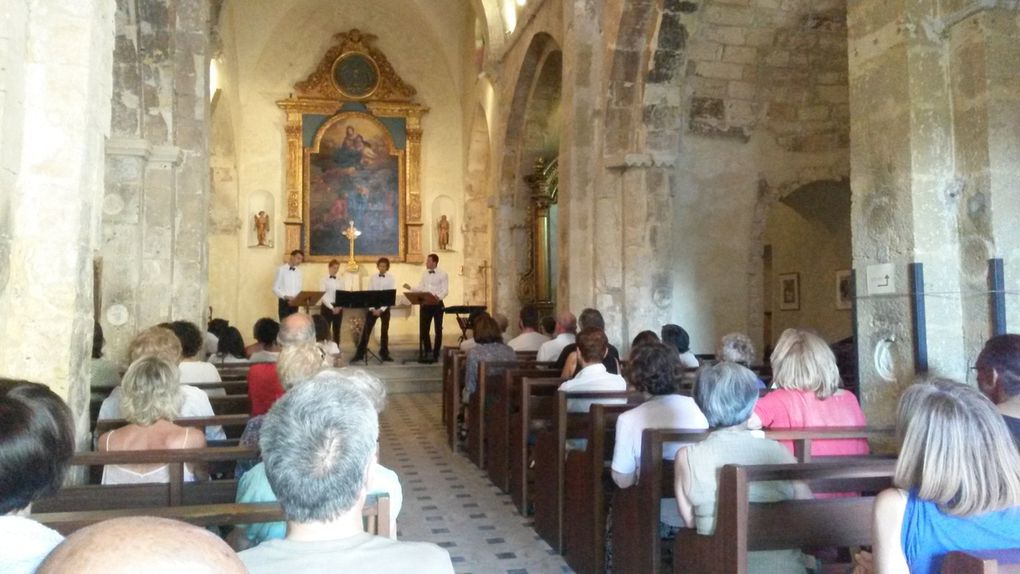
[748,329,868,457]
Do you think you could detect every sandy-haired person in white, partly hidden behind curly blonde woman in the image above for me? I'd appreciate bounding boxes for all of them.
[97,326,226,440]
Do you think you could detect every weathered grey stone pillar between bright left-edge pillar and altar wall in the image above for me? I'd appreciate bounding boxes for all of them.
[101,0,209,361]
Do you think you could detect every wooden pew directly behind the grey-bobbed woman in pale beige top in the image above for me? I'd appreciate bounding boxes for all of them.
[673,460,896,574]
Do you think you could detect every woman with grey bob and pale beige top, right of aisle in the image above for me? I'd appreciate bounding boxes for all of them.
[673,362,811,574]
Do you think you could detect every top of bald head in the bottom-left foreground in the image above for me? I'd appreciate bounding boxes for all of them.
[37,516,247,574]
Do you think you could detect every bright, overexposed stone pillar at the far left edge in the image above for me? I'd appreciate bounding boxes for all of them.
[0,0,113,436]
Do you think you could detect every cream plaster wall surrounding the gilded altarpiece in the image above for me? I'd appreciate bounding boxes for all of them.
[210,0,473,341]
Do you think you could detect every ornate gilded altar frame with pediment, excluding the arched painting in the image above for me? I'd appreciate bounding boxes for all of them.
[276,30,428,263]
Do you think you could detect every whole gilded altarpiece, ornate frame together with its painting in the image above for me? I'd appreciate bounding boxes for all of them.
[277,30,427,263]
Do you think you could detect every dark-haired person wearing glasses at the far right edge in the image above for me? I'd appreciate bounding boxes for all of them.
[976,334,1020,440]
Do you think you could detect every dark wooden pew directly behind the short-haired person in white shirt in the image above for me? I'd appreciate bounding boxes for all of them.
[534,390,645,554]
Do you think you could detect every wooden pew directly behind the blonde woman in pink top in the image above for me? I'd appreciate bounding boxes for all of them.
[613,427,891,572]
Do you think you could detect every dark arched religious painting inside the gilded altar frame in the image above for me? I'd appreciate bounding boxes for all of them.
[305,111,405,260]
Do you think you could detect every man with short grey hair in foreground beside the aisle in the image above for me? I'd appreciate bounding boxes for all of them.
[240,371,453,574]
